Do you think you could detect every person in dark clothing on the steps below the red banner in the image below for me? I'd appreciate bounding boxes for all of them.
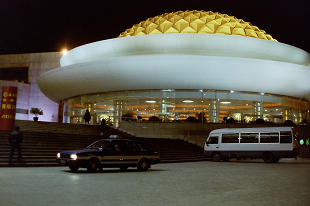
[9,126,23,165]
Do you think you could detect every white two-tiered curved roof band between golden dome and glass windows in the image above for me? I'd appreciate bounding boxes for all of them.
[37,34,310,102]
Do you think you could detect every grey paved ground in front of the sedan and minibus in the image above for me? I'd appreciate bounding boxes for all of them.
[0,159,310,206]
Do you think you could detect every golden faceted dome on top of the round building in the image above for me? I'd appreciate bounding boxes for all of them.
[118,10,277,41]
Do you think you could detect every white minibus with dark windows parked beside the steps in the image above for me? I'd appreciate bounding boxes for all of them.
[204,127,299,163]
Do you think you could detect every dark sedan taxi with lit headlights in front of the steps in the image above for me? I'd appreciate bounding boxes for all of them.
[56,139,159,172]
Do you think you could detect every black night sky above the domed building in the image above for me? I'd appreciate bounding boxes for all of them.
[0,0,310,54]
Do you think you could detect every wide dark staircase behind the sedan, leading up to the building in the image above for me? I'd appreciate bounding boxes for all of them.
[0,120,206,167]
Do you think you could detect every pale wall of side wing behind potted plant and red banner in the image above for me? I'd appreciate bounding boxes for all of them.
[0,52,62,122]
